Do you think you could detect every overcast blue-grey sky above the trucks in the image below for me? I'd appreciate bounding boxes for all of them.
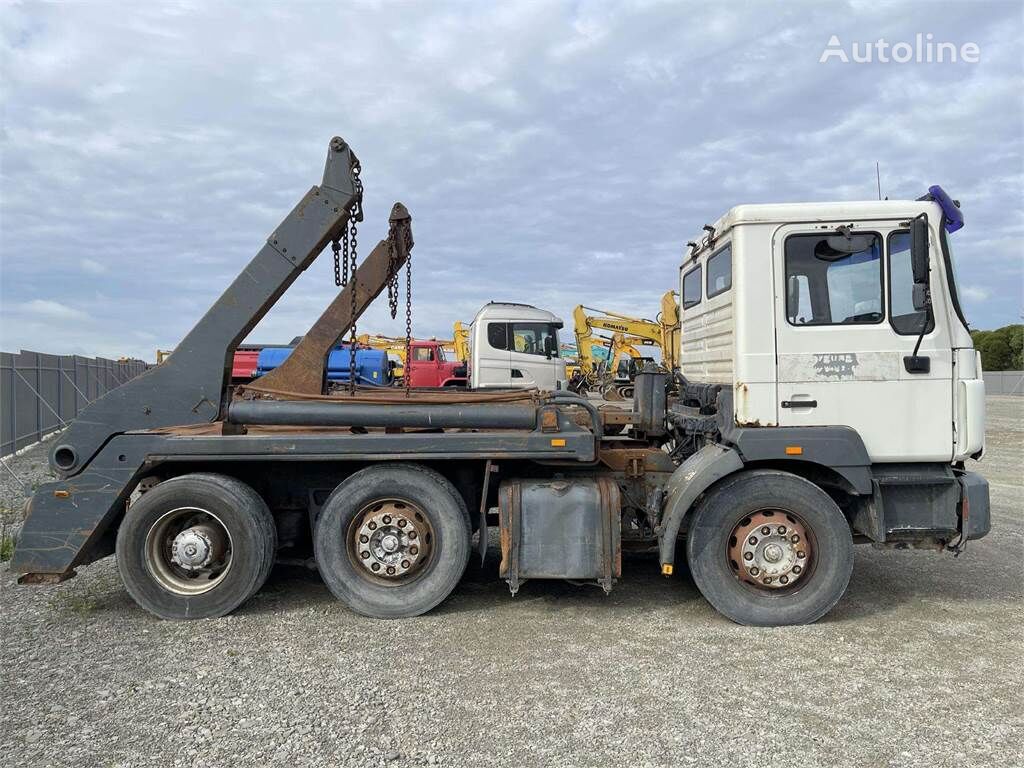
[0,0,1024,359]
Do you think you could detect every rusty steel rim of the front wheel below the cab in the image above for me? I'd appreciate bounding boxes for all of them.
[725,509,817,595]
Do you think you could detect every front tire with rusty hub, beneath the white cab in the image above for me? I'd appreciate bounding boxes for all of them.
[686,470,853,627]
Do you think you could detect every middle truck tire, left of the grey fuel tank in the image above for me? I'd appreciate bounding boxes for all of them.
[313,464,471,618]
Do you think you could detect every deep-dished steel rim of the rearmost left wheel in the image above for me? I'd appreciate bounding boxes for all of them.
[143,507,233,597]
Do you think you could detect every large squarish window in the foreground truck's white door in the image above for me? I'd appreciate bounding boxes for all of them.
[785,232,885,326]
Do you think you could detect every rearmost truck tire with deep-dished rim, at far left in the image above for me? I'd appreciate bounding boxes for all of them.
[116,473,278,618]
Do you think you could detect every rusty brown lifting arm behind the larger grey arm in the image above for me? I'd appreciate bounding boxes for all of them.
[246,203,413,394]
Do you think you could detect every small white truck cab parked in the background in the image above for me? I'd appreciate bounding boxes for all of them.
[469,301,567,390]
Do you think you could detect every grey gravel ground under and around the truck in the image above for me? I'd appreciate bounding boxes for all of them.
[0,397,1024,768]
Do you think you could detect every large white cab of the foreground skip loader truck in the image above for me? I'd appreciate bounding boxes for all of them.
[680,186,985,464]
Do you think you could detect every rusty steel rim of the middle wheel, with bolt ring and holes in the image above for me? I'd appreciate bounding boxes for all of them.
[345,499,434,587]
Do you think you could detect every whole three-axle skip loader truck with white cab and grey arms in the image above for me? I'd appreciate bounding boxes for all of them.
[6,138,989,625]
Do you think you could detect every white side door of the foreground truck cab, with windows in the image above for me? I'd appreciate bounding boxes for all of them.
[772,221,953,462]
